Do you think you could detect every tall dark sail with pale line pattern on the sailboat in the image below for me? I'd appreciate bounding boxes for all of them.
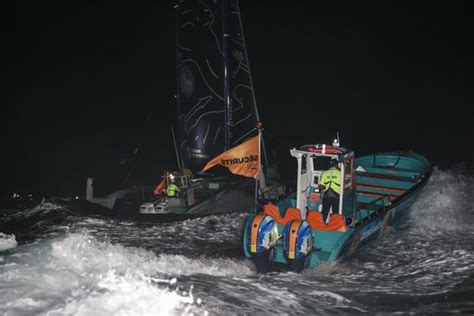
[176,0,258,170]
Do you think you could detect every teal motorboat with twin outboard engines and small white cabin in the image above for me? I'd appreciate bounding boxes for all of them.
[243,141,432,272]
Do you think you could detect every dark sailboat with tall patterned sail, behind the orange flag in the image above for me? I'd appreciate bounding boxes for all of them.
[87,0,285,214]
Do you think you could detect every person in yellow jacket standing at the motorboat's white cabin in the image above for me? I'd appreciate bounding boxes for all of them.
[320,159,341,224]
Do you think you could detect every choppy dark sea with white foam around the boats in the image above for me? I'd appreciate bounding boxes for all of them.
[0,169,474,315]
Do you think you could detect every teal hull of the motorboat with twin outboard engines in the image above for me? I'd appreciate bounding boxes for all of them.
[243,152,432,270]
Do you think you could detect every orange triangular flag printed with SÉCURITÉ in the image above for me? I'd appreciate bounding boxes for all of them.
[202,135,260,178]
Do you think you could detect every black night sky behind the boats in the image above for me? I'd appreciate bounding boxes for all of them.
[0,0,474,196]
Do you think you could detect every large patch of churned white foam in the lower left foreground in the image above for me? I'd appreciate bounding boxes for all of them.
[0,233,254,315]
